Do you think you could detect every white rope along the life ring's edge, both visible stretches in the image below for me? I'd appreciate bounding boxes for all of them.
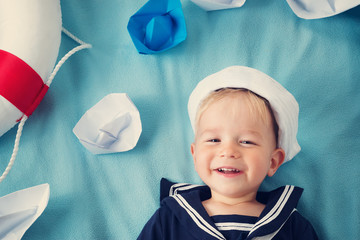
[0,28,92,183]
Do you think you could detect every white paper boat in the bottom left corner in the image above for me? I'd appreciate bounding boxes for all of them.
[0,184,50,240]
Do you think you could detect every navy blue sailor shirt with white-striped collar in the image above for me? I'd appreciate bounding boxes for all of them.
[138,178,318,240]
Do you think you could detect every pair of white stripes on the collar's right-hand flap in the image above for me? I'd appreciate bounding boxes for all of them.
[249,185,295,235]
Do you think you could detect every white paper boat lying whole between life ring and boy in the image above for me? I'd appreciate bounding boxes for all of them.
[73,93,142,154]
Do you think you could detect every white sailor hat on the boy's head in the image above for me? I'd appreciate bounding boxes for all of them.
[188,66,301,162]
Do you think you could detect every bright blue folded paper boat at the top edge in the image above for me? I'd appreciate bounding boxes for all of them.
[127,0,187,54]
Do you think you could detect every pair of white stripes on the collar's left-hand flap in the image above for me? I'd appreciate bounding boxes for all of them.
[172,194,226,240]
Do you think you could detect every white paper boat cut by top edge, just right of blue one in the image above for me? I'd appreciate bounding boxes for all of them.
[191,0,246,11]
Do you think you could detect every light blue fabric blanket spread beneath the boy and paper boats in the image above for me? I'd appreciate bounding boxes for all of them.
[0,0,360,239]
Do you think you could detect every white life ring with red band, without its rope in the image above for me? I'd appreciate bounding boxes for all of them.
[0,0,62,136]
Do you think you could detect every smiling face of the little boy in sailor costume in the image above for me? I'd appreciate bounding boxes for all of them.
[191,93,284,200]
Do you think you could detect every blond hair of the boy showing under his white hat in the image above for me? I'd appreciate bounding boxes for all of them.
[195,88,279,143]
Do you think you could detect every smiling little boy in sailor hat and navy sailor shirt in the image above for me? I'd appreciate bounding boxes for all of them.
[138,66,317,240]
